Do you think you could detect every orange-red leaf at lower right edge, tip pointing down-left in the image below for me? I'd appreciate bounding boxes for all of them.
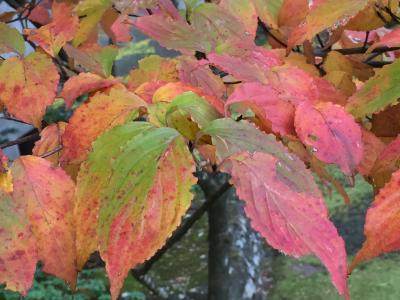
[350,171,400,272]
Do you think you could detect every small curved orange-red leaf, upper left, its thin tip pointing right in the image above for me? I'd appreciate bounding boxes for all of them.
[60,73,118,108]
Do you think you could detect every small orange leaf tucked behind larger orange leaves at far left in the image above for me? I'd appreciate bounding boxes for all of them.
[32,122,67,166]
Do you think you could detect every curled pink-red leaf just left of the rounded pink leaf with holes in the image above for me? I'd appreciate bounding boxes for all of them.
[226,82,294,135]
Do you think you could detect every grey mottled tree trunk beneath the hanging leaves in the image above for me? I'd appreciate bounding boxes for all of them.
[203,174,271,300]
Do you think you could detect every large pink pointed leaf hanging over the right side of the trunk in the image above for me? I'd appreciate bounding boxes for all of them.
[222,152,349,298]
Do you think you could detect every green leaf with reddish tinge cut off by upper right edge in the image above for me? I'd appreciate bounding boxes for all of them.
[346,59,400,118]
